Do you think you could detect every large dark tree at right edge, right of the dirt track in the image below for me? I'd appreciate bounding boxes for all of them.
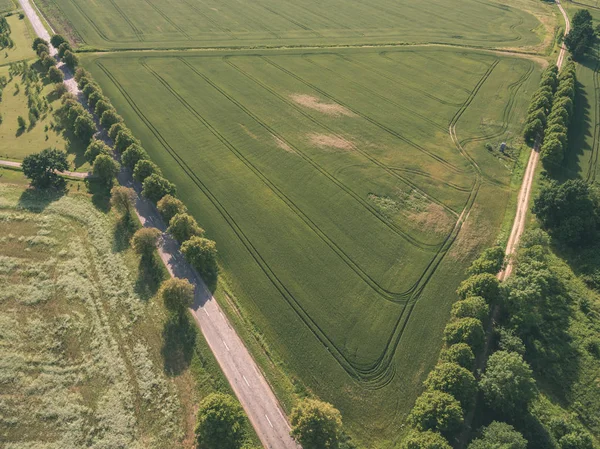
[532,179,600,247]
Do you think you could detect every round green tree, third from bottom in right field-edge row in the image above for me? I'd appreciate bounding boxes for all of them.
[424,363,477,408]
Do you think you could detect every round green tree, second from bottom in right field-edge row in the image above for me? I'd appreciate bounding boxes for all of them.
[408,391,463,436]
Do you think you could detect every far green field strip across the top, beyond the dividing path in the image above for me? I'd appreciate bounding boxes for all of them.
[39,0,542,49]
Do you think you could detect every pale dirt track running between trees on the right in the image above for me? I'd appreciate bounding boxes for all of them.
[498,0,571,281]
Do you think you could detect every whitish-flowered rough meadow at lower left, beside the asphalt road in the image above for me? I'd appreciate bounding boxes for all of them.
[0,183,255,448]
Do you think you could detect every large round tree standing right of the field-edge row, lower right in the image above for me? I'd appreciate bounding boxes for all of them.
[479,351,537,418]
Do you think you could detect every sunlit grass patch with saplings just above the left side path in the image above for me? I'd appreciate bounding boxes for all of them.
[0,67,90,172]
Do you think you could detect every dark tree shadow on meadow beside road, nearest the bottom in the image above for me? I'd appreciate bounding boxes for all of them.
[161,314,197,376]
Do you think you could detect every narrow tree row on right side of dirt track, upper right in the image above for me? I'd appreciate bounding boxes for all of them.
[540,61,575,173]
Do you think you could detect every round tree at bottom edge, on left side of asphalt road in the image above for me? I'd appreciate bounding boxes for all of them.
[195,393,245,449]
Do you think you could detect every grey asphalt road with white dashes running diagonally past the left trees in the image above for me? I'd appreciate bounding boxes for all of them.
[19,0,300,449]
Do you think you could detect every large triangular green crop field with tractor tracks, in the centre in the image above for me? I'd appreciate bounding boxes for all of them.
[84,47,540,447]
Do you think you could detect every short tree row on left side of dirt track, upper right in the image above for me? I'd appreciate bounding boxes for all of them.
[523,66,558,144]
